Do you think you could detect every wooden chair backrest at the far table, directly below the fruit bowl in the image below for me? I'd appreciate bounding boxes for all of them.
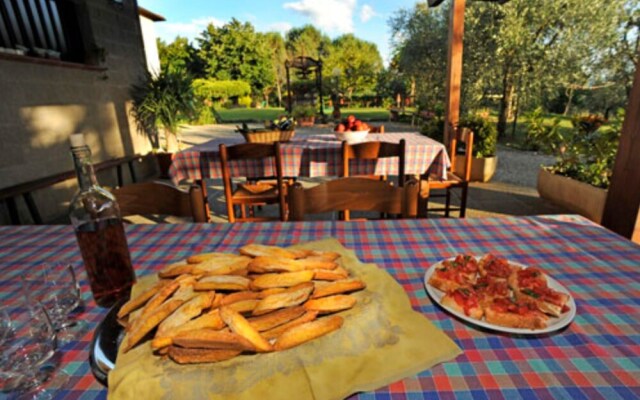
[342,139,406,186]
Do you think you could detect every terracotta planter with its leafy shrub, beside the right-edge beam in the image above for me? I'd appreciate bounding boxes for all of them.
[538,113,624,223]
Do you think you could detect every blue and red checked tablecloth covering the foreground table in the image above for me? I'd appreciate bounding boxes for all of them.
[0,216,640,399]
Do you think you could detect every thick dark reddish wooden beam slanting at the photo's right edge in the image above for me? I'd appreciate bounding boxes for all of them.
[602,61,640,243]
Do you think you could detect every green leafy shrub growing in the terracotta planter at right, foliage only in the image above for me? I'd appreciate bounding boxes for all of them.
[548,110,624,189]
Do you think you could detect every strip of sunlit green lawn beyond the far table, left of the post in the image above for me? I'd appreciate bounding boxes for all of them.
[216,108,389,123]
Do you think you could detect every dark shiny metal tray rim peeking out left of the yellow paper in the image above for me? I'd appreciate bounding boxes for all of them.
[89,298,127,387]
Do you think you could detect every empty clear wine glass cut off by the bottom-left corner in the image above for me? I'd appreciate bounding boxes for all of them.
[0,303,56,399]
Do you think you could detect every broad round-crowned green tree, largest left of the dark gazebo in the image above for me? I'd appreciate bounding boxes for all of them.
[196,18,274,95]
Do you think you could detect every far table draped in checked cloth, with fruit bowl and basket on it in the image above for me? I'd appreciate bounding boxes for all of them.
[169,133,450,184]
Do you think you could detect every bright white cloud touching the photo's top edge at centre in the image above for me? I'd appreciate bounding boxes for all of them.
[283,0,356,33]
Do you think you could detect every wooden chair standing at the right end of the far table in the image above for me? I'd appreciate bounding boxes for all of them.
[418,128,473,218]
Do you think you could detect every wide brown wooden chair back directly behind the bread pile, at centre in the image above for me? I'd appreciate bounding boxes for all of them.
[288,177,418,221]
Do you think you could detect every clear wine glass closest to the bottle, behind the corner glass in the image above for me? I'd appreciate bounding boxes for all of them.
[22,264,82,341]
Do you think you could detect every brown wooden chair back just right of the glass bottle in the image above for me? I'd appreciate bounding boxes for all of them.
[112,182,207,222]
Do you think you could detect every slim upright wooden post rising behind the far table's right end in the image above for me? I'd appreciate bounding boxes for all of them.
[444,0,465,146]
